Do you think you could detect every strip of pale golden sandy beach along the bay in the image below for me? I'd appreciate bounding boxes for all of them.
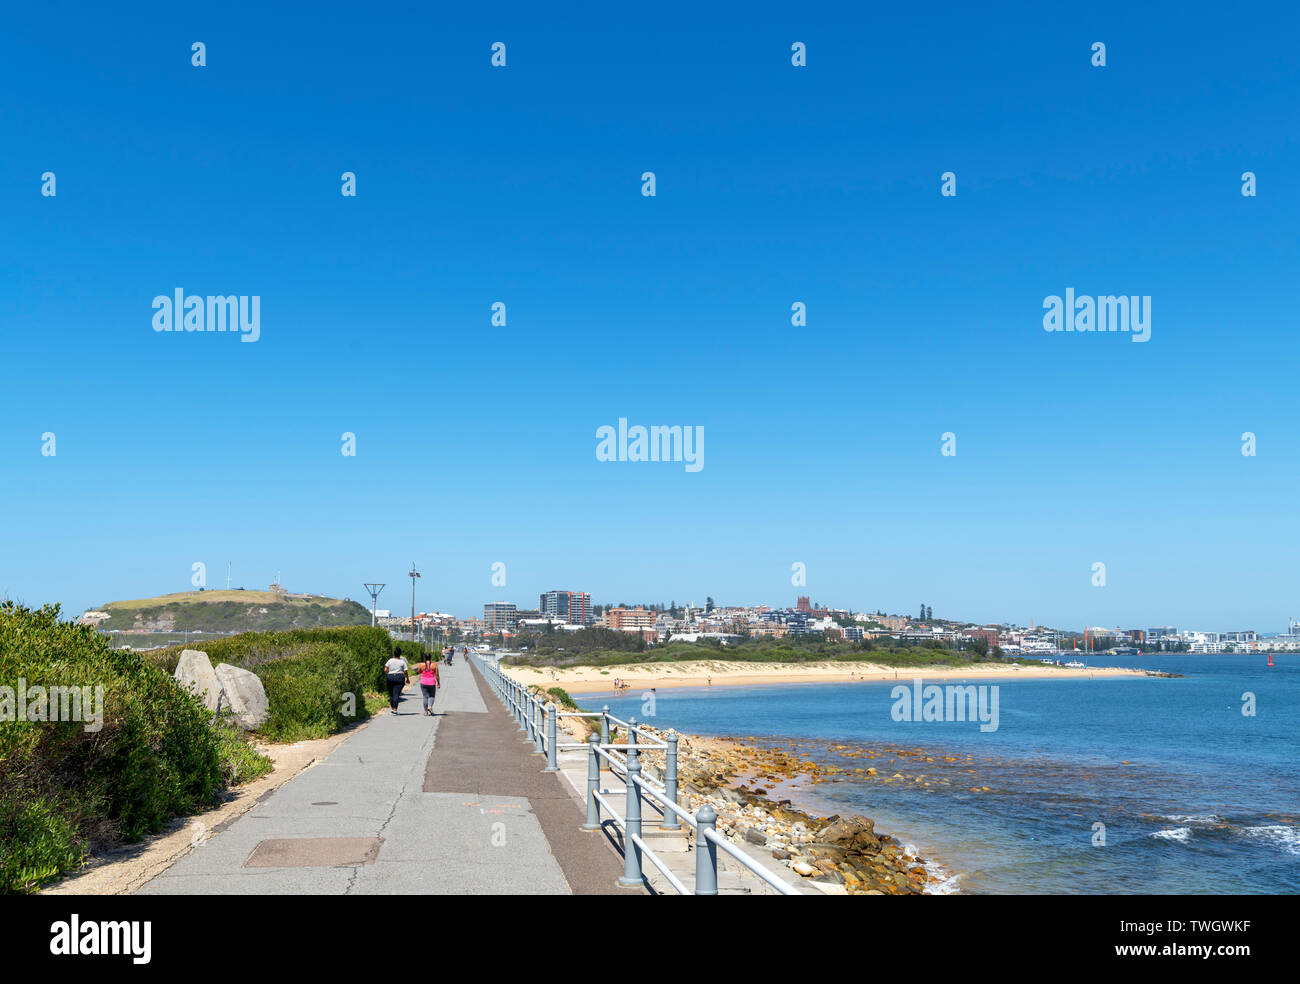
[503,659,1149,694]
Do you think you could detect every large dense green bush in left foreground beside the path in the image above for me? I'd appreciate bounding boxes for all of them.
[0,602,270,893]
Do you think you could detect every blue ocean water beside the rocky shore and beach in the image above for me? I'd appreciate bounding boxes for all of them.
[579,654,1300,894]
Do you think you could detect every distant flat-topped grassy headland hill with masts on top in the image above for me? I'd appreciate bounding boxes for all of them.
[96,590,371,633]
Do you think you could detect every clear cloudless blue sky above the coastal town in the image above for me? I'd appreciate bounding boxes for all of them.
[0,3,1300,630]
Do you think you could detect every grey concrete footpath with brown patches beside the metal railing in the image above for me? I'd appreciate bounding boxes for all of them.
[140,662,641,894]
